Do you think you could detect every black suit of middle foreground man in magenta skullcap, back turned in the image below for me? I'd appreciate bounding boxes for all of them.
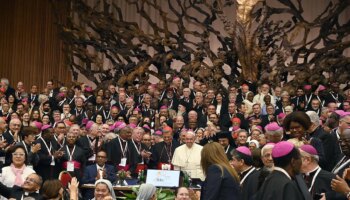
[255,170,304,200]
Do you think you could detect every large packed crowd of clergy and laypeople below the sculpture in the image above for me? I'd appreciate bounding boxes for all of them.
[0,77,350,200]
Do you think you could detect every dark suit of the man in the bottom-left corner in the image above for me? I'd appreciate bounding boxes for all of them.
[0,182,43,200]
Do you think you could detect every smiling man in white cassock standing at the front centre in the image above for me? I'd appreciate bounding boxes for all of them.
[172,131,204,180]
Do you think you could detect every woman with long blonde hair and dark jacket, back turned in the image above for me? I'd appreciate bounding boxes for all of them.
[201,142,241,200]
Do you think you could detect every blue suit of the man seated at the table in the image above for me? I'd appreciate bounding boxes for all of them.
[81,164,116,199]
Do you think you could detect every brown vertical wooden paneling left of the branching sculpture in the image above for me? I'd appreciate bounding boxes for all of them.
[0,0,72,89]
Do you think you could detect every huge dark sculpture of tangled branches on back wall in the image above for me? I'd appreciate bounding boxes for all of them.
[53,0,350,88]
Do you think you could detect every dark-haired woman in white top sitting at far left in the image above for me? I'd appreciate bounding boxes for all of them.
[0,145,35,199]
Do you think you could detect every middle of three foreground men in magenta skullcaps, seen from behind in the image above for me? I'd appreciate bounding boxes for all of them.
[256,141,305,200]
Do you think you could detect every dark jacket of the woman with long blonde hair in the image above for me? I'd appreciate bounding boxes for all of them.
[201,165,241,200]
